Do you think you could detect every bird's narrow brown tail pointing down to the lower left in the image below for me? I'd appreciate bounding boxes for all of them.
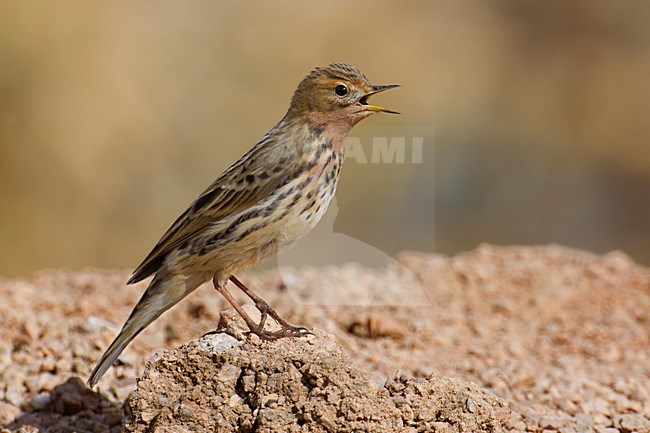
[88,274,208,388]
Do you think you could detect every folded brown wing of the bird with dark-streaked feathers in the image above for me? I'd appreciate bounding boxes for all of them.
[128,137,293,284]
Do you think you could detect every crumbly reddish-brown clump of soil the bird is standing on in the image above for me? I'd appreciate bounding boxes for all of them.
[126,332,510,433]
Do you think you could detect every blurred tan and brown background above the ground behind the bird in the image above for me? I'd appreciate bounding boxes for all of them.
[0,0,650,276]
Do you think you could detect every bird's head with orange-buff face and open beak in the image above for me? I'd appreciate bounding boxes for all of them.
[288,63,399,130]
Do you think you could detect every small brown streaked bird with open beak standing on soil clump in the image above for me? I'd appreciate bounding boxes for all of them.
[87,63,399,388]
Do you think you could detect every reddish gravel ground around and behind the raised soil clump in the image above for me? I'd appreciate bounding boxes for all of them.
[0,245,650,433]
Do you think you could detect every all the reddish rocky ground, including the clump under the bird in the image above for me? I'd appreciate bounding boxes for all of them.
[0,246,650,433]
